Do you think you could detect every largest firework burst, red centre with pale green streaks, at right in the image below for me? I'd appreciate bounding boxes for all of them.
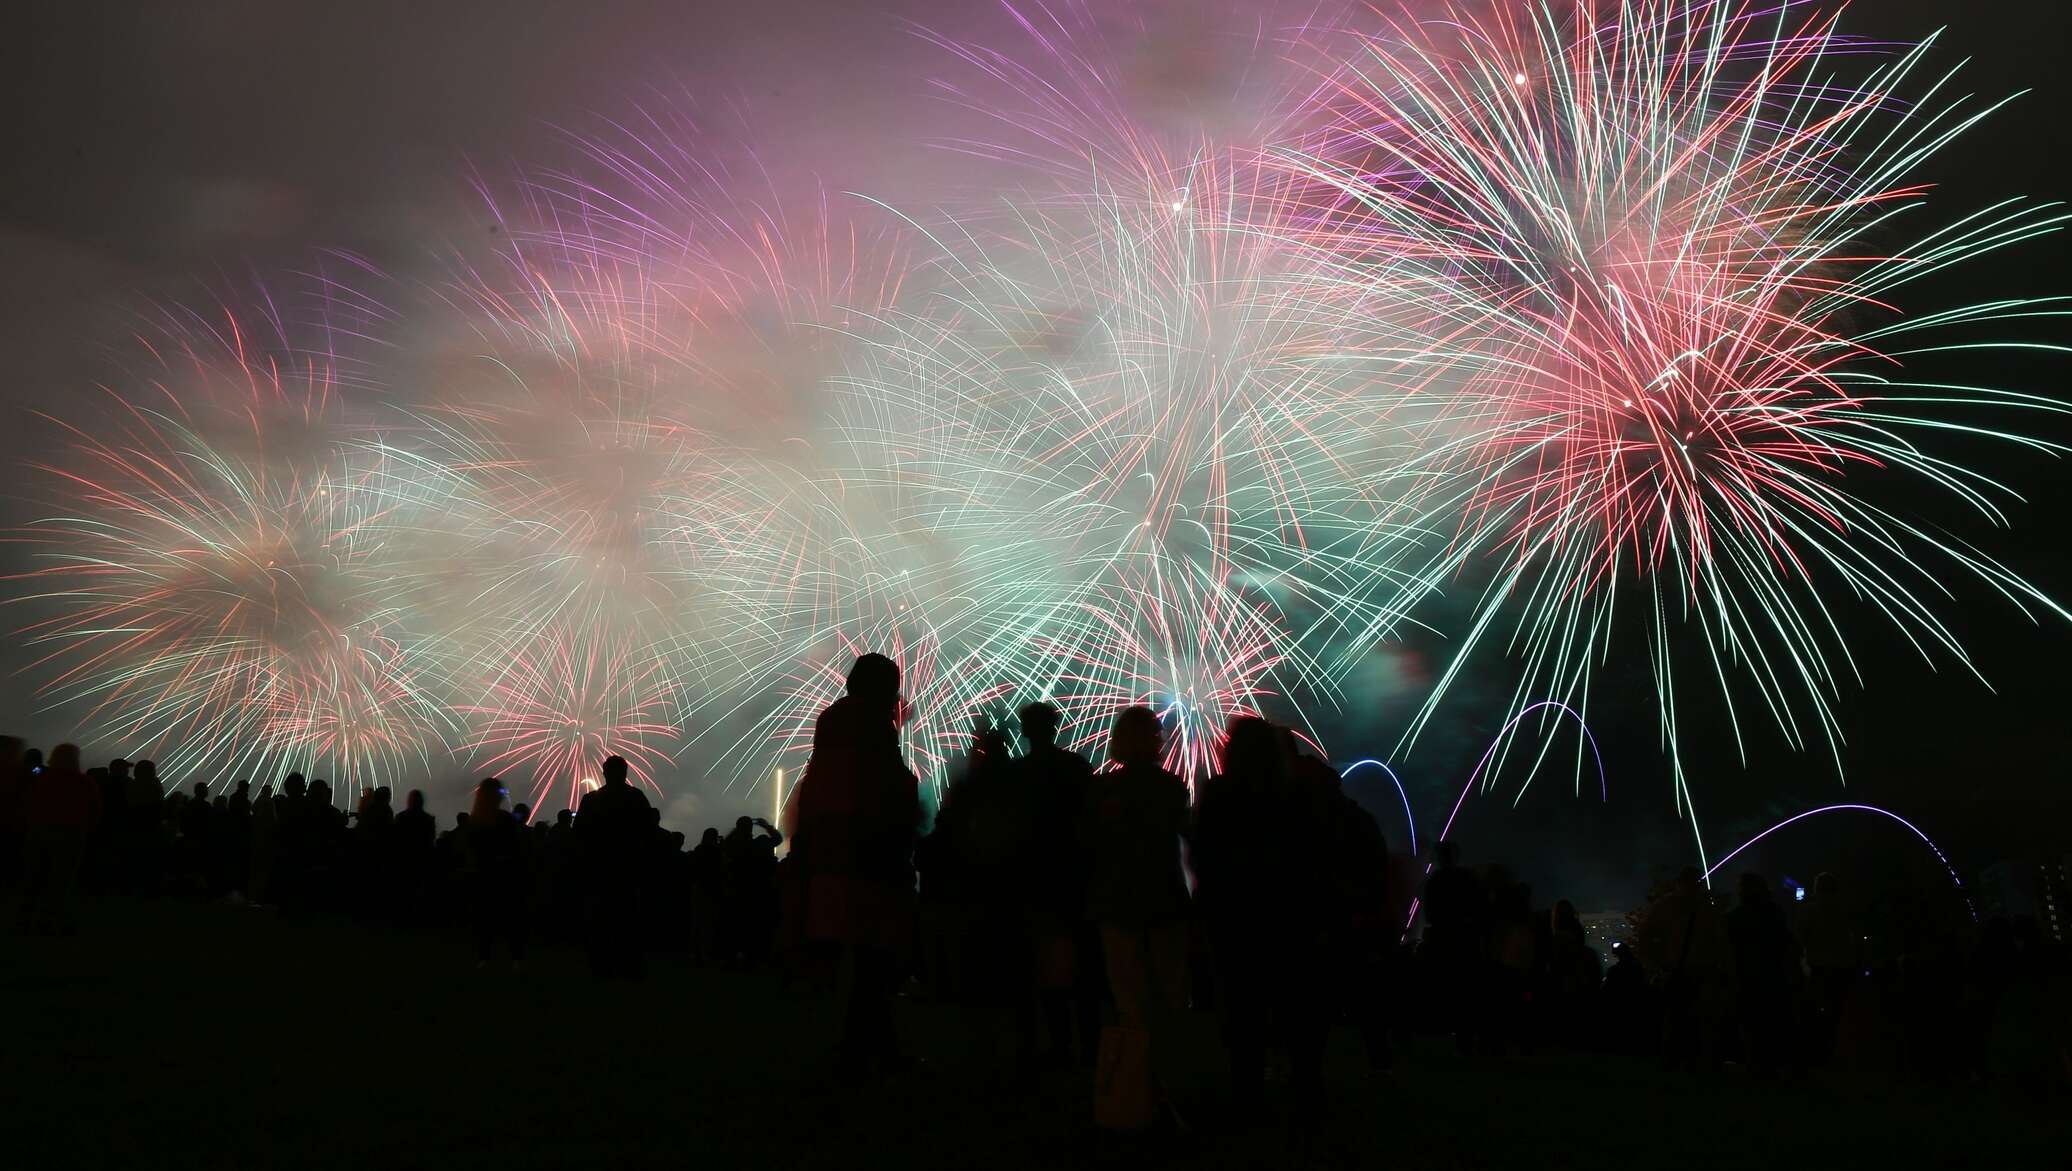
[1287,0,2062,841]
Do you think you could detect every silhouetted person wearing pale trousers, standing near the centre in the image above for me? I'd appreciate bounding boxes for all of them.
[1080,707,1187,1127]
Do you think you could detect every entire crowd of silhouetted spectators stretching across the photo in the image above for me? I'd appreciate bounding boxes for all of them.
[0,655,2072,1127]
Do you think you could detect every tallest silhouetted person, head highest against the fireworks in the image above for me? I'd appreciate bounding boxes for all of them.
[787,655,920,1078]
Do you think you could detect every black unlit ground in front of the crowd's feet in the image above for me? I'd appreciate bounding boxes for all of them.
[0,902,2072,1171]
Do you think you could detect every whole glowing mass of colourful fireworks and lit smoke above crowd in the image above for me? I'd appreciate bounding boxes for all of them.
[19,0,2064,829]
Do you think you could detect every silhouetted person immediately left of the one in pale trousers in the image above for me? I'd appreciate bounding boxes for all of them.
[1015,703,1102,1059]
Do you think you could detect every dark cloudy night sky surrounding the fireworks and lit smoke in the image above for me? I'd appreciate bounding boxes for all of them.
[0,0,2072,904]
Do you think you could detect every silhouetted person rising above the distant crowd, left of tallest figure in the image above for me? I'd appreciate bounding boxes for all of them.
[574,756,653,978]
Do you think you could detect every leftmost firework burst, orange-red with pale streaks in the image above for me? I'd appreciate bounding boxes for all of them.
[25,283,443,792]
